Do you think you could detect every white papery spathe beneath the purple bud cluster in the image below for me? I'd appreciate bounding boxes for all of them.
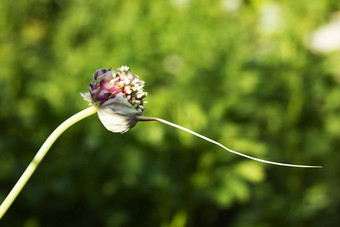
[98,94,142,133]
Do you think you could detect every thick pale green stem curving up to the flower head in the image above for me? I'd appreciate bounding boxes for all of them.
[0,106,97,219]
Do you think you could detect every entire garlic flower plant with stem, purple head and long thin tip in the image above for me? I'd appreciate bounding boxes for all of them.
[0,66,322,219]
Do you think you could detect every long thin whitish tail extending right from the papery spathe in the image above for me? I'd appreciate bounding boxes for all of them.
[138,116,323,168]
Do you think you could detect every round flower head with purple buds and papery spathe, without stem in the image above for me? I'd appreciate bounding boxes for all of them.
[81,66,147,133]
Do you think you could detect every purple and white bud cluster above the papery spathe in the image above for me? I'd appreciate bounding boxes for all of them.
[82,66,147,113]
